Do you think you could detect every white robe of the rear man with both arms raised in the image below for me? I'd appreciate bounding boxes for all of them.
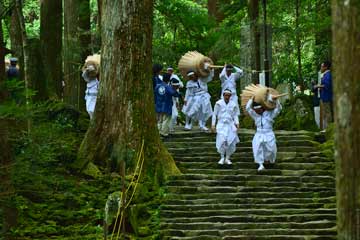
[219,67,243,105]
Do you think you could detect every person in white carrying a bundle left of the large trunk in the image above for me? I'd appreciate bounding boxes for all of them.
[82,65,99,119]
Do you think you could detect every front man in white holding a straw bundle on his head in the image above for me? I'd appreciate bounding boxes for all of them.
[246,94,282,171]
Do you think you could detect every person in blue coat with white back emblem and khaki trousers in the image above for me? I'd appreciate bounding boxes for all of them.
[154,73,180,137]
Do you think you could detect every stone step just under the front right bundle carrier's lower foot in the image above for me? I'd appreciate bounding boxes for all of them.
[182,168,335,176]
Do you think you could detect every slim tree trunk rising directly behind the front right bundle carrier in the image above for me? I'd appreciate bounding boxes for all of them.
[248,0,261,84]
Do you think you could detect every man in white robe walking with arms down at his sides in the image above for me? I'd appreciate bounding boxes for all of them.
[211,89,240,165]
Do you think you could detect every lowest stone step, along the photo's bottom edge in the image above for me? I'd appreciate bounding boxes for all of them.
[161,234,337,240]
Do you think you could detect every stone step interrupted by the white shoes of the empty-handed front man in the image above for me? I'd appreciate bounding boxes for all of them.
[175,154,335,164]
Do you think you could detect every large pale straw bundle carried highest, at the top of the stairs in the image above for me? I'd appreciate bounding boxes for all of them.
[178,51,214,78]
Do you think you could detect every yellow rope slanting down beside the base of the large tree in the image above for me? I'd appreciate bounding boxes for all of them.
[111,140,145,240]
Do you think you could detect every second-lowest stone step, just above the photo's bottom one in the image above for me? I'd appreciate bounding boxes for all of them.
[160,220,336,230]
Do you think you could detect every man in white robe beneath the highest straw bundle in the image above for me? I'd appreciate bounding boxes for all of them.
[182,70,214,131]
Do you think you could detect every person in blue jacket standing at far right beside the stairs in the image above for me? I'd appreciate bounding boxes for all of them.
[317,61,333,129]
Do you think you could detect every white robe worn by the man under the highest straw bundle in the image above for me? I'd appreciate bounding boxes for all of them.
[182,71,214,122]
